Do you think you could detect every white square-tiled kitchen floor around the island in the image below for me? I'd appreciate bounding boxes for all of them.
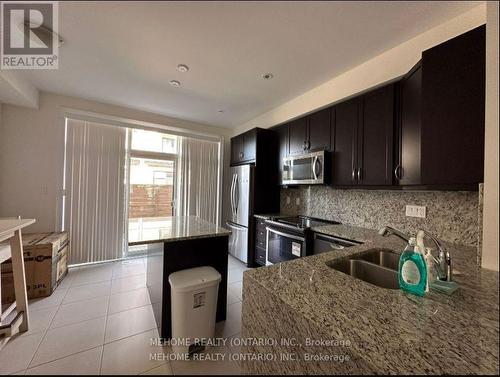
[0,256,247,374]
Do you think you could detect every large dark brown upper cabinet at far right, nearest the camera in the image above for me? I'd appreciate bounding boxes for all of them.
[395,26,486,189]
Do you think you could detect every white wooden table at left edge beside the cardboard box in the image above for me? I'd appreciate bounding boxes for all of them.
[0,219,36,342]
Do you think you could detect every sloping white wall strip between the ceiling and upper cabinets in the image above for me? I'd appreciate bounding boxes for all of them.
[233,4,486,135]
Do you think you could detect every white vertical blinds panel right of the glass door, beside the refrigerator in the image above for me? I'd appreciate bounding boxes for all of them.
[175,137,220,224]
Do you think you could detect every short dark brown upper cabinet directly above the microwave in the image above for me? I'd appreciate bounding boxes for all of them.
[289,108,331,155]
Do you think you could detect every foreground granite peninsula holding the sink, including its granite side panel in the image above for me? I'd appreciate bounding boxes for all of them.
[241,225,499,374]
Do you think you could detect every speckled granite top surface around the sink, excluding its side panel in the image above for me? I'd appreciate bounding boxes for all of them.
[244,225,499,374]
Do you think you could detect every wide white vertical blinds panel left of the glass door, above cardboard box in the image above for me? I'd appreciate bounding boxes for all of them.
[64,119,127,264]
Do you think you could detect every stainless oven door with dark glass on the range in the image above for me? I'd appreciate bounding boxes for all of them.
[266,227,306,265]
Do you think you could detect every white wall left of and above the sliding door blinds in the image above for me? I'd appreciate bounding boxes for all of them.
[0,92,229,231]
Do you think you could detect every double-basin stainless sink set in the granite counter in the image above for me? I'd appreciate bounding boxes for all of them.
[327,249,399,289]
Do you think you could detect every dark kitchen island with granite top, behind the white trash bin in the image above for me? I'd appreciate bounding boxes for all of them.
[129,216,231,339]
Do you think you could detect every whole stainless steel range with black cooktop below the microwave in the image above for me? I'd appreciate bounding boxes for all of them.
[266,216,340,265]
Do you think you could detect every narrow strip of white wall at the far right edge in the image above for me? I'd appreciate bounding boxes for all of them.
[482,1,499,271]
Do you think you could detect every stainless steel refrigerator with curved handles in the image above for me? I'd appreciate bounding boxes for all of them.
[226,165,254,263]
